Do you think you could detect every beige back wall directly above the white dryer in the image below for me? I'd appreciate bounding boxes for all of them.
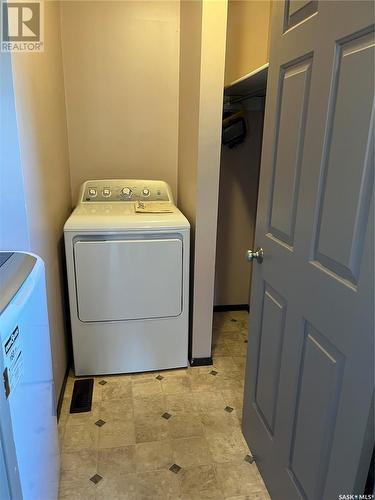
[62,1,179,203]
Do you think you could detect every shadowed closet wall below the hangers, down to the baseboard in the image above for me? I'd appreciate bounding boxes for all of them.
[215,106,263,305]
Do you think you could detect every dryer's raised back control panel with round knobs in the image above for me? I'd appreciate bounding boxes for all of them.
[79,179,173,203]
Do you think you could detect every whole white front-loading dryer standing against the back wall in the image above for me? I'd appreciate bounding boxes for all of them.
[64,179,190,376]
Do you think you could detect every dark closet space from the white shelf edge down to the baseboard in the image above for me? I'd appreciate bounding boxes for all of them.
[214,64,268,311]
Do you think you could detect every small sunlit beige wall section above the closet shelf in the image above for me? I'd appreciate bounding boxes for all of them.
[225,0,272,85]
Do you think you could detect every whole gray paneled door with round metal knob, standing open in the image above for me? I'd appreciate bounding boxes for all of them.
[243,1,374,500]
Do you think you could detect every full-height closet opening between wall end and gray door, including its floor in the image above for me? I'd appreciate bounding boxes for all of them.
[212,1,271,456]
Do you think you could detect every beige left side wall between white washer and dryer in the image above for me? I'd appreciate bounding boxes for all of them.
[12,2,71,394]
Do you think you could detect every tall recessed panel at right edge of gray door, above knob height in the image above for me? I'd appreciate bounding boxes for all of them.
[314,33,374,285]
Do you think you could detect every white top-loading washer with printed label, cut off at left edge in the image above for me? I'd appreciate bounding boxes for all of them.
[0,252,59,500]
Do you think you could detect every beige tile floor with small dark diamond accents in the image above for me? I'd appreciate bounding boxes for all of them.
[59,311,270,500]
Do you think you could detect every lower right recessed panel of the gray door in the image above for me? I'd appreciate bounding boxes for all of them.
[290,323,344,498]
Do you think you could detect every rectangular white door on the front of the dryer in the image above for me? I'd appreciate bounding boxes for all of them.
[74,238,182,321]
